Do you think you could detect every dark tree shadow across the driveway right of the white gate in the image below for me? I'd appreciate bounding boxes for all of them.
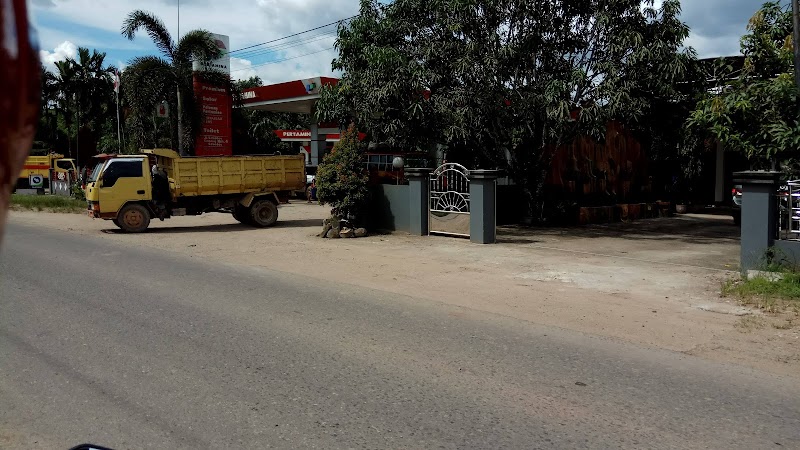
[497,215,740,244]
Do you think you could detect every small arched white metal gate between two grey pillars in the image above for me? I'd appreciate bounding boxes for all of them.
[428,163,470,237]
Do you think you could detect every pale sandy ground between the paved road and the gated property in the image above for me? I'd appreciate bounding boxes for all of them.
[10,203,800,378]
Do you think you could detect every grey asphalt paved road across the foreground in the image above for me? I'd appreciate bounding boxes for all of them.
[0,225,800,449]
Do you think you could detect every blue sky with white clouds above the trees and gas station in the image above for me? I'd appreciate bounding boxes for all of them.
[29,0,765,84]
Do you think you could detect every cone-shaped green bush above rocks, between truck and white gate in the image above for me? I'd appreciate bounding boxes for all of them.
[316,125,369,223]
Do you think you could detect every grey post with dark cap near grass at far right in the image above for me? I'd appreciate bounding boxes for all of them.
[733,171,781,273]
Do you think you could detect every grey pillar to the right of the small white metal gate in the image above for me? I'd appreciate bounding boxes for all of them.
[469,170,498,244]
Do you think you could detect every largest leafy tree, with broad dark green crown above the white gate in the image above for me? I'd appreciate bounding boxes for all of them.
[317,0,694,218]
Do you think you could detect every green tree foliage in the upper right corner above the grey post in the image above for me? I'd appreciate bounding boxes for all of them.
[687,2,800,168]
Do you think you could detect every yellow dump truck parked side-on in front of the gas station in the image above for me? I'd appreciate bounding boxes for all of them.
[86,149,306,233]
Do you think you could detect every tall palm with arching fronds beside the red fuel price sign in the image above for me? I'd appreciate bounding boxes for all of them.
[122,10,223,155]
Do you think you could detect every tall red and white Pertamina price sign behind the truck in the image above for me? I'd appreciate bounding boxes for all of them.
[193,34,233,156]
